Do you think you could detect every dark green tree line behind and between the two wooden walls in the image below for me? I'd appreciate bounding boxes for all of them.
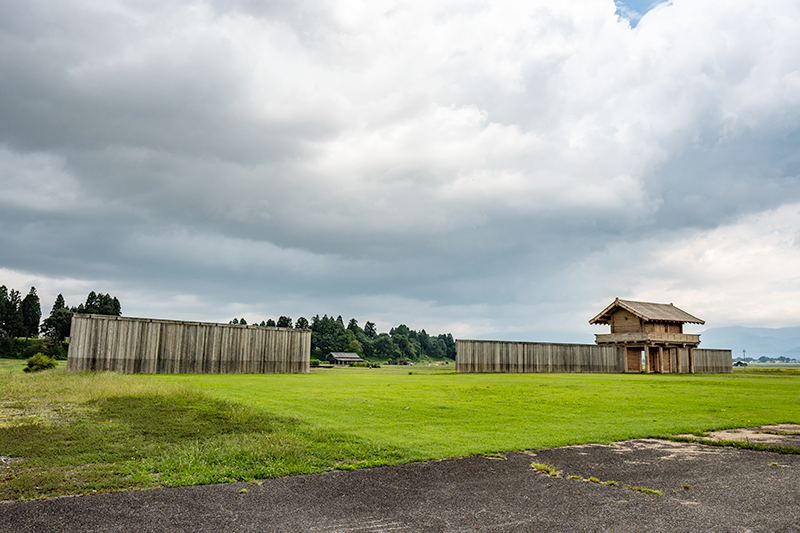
[229,315,456,360]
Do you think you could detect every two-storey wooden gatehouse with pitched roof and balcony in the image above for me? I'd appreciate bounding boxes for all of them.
[589,298,705,374]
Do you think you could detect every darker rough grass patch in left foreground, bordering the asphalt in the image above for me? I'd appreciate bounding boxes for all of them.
[0,393,404,500]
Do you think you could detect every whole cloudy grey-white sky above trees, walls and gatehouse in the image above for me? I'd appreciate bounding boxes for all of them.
[0,0,800,343]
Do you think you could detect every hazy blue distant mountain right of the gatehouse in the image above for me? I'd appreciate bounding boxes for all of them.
[700,326,800,359]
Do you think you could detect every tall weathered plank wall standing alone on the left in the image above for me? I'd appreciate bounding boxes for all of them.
[67,314,311,374]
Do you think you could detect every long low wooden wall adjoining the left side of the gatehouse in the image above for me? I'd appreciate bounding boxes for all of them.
[456,339,625,372]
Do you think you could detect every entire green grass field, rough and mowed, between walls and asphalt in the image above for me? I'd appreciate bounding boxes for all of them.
[0,362,800,500]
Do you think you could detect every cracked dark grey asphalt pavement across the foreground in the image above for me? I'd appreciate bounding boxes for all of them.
[0,439,800,533]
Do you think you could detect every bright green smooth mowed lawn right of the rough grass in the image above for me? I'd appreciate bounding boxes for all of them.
[155,364,800,460]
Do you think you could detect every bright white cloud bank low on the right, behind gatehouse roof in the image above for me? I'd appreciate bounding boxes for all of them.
[569,203,800,327]
